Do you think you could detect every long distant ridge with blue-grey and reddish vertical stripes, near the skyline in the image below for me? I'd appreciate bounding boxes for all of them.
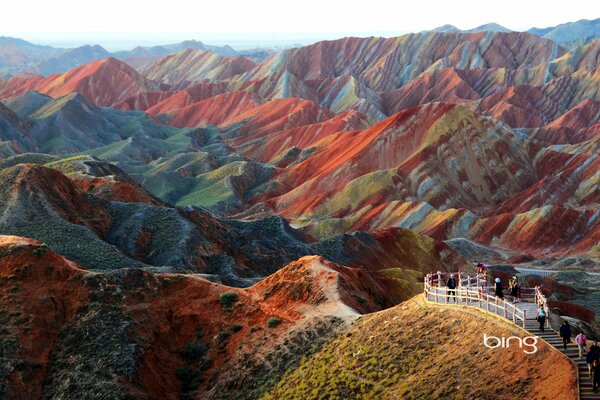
[250,32,565,91]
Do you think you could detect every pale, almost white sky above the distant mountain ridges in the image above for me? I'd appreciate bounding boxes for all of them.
[0,0,600,49]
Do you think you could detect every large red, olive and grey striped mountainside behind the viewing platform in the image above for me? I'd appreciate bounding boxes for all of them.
[242,103,600,254]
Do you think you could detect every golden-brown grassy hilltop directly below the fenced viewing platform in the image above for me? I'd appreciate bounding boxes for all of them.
[263,296,578,400]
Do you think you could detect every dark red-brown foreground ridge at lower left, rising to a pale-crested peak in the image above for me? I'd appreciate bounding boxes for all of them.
[0,236,419,399]
